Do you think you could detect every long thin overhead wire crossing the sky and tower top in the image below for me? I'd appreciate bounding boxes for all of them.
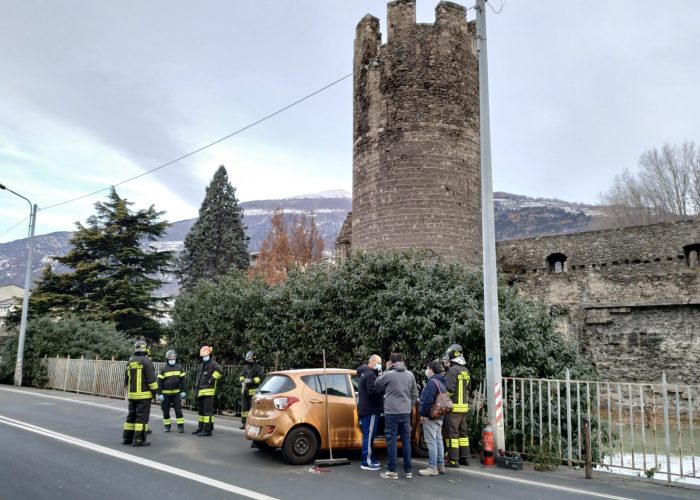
[39,7,476,210]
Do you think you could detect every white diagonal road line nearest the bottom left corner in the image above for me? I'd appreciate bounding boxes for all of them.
[0,415,277,500]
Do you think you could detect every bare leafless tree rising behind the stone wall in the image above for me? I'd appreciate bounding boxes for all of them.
[599,142,700,227]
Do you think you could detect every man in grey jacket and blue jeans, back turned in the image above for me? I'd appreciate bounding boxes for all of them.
[375,352,418,479]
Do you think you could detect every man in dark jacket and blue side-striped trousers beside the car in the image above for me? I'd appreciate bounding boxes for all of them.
[357,354,384,470]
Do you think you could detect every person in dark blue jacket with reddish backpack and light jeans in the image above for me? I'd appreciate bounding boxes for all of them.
[418,361,447,476]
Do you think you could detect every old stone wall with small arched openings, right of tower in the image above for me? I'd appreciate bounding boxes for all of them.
[496,220,700,383]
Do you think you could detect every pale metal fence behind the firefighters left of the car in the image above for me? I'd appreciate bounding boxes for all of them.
[42,357,239,408]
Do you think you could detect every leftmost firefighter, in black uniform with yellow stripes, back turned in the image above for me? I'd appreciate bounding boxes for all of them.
[122,340,158,446]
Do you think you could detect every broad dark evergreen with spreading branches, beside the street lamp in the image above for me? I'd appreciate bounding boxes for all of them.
[15,188,172,341]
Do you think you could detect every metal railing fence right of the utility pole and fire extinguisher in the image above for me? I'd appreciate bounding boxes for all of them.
[503,370,700,481]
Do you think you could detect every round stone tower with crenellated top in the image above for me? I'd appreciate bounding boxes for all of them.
[348,0,481,266]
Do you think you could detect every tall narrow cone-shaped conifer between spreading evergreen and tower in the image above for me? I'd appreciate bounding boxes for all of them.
[178,165,250,287]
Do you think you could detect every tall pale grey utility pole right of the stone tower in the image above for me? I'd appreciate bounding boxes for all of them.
[476,0,506,452]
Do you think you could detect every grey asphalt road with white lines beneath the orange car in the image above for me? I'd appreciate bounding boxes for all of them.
[0,386,699,500]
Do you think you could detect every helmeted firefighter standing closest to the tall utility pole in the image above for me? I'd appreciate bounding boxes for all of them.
[445,344,471,468]
